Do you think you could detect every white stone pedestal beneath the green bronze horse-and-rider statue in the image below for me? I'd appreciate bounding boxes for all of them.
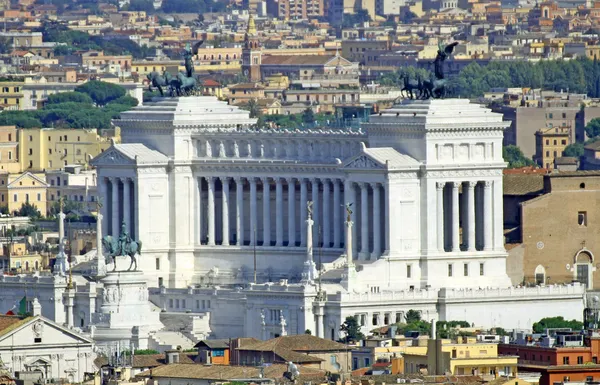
[92,257,163,349]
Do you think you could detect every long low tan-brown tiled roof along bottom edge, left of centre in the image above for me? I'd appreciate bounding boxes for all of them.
[137,363,325,380]
